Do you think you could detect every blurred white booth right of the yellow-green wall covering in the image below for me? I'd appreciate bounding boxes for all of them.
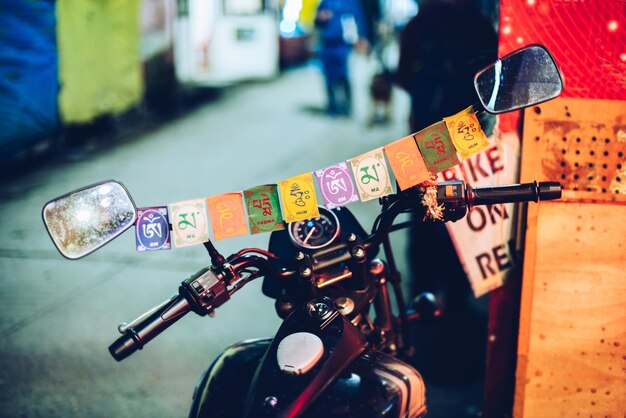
[174,0,278,86]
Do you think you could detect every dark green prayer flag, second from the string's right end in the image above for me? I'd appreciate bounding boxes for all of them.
[414,121,459,174]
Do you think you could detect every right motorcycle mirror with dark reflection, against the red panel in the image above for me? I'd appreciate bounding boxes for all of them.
[474,45,563,114]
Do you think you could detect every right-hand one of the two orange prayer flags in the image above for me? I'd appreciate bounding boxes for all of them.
[384,135,431,190]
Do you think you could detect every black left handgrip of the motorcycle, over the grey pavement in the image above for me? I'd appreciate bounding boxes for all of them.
[109,295,190,361]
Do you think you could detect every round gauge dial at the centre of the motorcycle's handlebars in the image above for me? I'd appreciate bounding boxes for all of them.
[289,207,339,250]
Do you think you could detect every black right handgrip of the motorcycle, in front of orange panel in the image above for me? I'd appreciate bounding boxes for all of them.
[467,181,562,206]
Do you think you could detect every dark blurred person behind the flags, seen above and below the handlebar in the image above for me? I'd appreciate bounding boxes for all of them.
[396,0,498,390]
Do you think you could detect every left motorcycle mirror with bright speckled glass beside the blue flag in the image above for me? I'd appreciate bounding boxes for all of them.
[42,180,137,260]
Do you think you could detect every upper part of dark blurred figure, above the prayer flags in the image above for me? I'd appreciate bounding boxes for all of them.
[396,0,498,132]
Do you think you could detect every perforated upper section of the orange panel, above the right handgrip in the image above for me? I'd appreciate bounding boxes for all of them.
[522,99,626,200]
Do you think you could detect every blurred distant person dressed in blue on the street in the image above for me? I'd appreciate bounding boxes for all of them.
[315,0,368,116]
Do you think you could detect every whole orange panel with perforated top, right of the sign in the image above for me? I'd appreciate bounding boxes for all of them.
[514,99,626,418]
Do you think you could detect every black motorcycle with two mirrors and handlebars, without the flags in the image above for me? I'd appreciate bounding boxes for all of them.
[43,45,562,418]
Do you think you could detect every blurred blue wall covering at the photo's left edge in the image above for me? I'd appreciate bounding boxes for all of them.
[0,1,59,163]
